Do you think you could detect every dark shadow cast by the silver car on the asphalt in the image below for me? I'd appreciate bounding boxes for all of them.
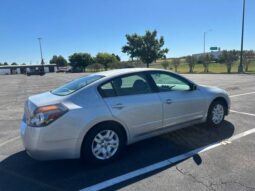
[0,121,235,190]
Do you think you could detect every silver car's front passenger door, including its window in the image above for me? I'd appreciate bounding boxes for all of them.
[150,71,206,127]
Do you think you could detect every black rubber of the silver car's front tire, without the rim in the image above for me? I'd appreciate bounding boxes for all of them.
[207,100,227,127]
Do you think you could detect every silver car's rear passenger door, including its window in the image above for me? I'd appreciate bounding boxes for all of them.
[99,73,163,136]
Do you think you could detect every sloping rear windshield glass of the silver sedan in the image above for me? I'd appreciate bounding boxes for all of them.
[51,74,104,96]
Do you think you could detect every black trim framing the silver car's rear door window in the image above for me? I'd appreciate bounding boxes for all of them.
[97,71,156,98]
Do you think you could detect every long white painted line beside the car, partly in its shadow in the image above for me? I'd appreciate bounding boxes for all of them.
[80,128,255,191]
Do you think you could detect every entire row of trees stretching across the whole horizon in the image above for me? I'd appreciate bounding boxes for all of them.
[0,30,255,73]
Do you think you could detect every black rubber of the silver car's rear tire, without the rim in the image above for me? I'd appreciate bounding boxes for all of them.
[81,124,125,164]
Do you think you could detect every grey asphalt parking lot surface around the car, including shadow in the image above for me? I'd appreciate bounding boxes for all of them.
[0,74,255,191]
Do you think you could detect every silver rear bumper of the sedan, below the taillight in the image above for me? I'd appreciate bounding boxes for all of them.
[20,121,80,160]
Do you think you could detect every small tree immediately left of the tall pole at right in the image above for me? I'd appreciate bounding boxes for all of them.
[219,50,239,73]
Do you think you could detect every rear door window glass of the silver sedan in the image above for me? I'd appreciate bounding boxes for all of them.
[100,74,152,97]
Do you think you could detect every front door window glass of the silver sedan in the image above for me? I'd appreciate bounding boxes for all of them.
[151,72,190,92]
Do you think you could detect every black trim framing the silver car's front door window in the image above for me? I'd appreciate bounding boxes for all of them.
[147,70,194,93]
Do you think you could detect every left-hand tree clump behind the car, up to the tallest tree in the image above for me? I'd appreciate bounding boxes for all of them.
[46,31,168,72]
